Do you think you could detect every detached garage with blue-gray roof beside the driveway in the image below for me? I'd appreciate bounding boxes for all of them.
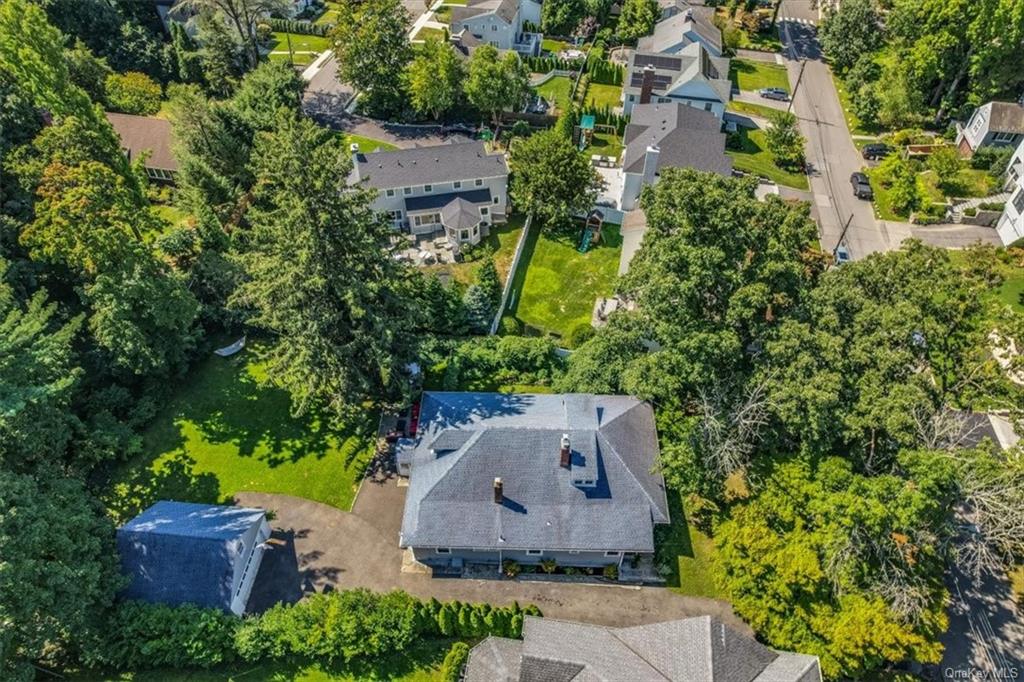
[117,501,270,615]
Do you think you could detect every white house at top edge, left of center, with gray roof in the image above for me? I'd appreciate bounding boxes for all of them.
[452,0,541,56]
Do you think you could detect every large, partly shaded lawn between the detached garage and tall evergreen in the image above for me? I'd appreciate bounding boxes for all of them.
[102,343,377,519]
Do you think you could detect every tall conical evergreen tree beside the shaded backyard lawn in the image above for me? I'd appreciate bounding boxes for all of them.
[233,116,416,412]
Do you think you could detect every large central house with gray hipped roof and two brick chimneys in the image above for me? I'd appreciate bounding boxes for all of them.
[396,392,669,568]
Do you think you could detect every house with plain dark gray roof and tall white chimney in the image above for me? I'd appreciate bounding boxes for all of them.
[618,103,732,211]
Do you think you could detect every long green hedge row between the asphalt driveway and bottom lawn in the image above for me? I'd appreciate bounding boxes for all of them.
[88,589,541,670]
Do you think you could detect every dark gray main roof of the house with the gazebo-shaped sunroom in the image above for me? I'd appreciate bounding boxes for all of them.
[350,141,509,189]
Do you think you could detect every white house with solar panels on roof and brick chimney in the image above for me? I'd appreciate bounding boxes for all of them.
[623,42,732,118]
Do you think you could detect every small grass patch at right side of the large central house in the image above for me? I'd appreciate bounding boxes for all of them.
[654,491,726,599]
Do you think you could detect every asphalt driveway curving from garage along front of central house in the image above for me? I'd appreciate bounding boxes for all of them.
[237,478,751,633]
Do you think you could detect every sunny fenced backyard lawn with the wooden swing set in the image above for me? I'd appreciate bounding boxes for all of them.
[509,223,623,336]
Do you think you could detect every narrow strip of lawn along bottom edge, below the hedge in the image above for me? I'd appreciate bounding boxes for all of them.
[70,639,456,682]
